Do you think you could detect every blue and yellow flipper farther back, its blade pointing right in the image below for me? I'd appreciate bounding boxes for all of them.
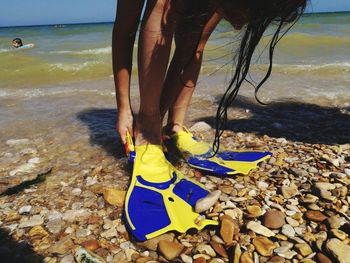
[164,128,272,175]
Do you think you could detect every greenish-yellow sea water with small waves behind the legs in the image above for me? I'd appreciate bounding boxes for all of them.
[0,13,350,151]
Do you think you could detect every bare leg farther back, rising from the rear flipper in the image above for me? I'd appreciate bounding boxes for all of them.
[161,12,221,131]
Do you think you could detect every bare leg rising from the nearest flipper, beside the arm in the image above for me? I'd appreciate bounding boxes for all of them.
[135,0,174,145]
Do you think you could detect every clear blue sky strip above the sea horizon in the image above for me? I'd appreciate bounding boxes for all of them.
[0,0,350,27]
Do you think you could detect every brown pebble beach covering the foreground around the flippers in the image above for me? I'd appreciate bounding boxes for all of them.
[0,102,350,263]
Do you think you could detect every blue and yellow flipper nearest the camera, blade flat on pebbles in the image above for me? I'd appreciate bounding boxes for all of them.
[125,145,218,241]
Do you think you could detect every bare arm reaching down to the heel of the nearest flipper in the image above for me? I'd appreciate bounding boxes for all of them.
[112,0,145,143]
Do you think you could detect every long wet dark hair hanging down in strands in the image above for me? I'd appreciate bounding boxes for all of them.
[213,0,308,154]
